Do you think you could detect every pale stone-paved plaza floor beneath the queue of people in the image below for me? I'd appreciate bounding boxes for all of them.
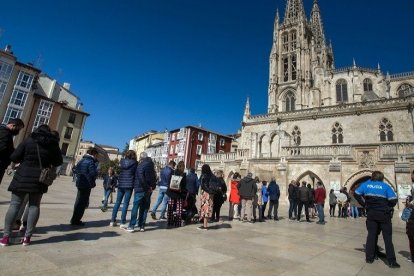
[0,176,414,276]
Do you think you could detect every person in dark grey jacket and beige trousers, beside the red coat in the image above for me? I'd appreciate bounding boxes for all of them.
[237,172,257,223]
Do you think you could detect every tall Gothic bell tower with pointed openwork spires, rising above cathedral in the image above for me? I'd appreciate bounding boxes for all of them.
[268,0,333,113]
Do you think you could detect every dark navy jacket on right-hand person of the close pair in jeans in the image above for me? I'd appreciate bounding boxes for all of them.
[134,157,157,193]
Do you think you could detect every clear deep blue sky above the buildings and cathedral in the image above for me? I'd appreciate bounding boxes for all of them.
[0,0,414,149]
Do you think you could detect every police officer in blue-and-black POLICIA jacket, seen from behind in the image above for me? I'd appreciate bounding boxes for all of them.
[355,171,400,268]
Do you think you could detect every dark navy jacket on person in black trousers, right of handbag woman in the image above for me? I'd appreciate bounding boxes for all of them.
[75,154,98,189]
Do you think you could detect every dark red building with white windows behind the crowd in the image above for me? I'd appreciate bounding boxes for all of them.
[167,126,233,169]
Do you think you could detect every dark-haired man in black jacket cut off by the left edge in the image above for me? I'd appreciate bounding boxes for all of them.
[0,118,24,183]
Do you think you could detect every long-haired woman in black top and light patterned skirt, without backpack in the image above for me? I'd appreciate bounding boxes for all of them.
[197,164,217,230]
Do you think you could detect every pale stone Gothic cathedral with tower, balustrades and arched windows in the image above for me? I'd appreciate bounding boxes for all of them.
[202,0,414,196]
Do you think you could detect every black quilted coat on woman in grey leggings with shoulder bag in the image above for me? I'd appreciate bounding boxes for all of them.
[9,128,63,193]
